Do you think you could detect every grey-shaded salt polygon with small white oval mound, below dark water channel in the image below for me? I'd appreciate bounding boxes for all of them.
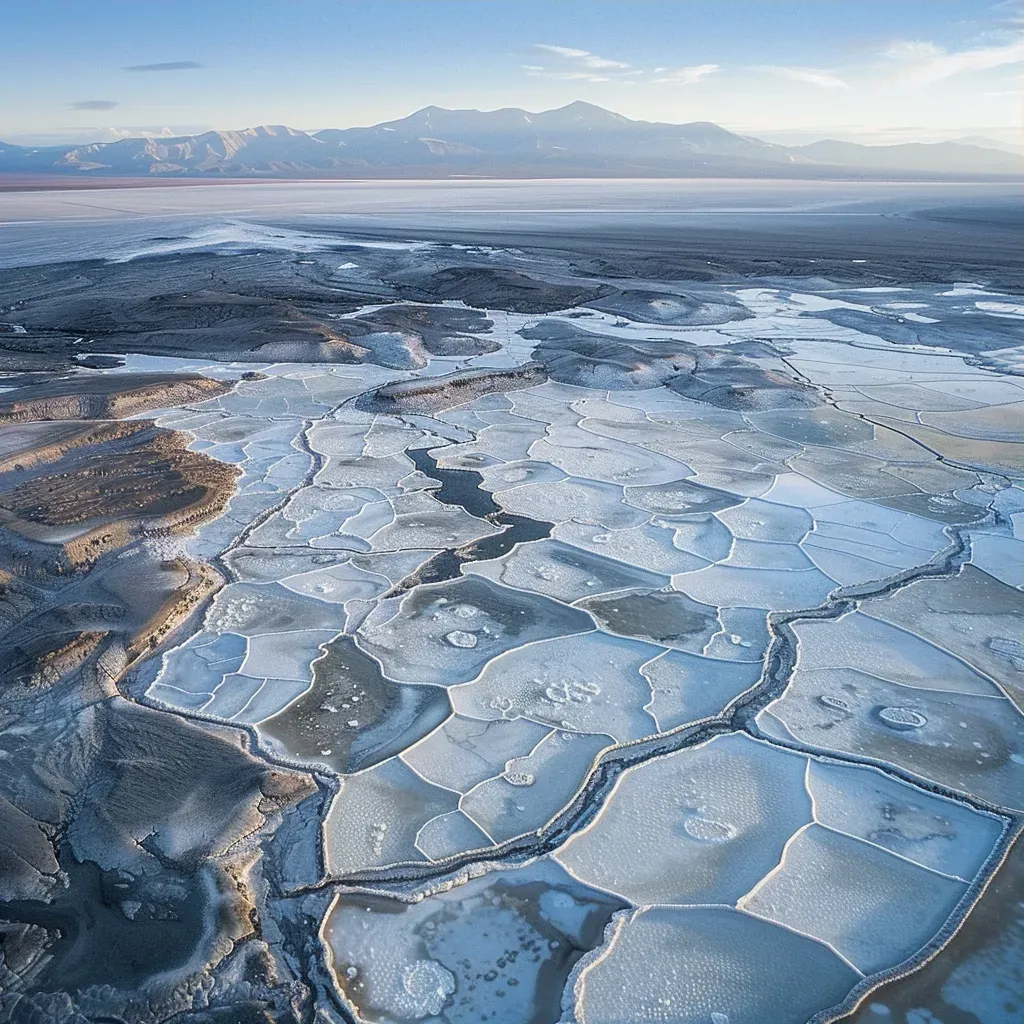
[358,577,594,684]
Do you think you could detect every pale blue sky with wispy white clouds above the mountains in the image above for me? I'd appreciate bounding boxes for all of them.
[0,0,1024,141]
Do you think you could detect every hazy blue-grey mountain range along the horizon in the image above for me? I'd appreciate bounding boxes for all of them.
[0,101,1024,178]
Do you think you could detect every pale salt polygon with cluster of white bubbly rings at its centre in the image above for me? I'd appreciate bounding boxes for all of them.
[451,631,664,742]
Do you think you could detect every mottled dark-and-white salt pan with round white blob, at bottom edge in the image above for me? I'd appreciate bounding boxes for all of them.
[324,860,621,1024]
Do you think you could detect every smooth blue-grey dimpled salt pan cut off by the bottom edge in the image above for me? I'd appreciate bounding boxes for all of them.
[573,906,861,1024]
